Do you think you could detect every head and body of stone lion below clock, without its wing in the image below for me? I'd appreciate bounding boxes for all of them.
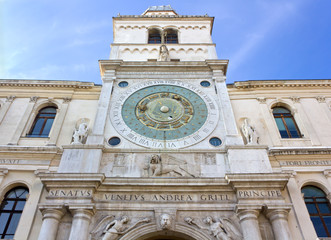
[149,155,194,177]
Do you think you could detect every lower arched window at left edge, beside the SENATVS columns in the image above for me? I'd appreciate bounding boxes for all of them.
[0,187,29,239]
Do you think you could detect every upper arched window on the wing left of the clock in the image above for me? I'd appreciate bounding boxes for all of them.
[28,107,56,137]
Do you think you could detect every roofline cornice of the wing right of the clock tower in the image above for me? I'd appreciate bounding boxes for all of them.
[232,79,331,89]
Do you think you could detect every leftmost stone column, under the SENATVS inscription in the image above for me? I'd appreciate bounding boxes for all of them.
[38,206,65,240]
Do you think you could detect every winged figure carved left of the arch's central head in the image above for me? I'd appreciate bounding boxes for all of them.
[91,216,151,240]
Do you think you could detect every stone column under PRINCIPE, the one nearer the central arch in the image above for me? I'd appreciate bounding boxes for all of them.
[237,208,262,240]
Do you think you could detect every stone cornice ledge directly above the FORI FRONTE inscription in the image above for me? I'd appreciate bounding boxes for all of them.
[269,147,331,156]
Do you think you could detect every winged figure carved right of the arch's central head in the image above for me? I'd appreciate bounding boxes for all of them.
[184,216,243,240]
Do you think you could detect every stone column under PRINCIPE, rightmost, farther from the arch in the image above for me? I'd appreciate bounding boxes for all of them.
[266,208,291,240]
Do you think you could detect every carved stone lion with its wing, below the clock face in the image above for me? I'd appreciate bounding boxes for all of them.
[146,155,195,177]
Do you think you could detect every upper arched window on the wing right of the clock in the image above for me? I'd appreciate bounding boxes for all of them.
[272,107,301,138]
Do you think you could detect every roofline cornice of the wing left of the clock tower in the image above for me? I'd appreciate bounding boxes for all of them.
[0,79,95,89]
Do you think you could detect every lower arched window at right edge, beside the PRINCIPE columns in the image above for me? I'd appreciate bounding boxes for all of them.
[301,186,331,237]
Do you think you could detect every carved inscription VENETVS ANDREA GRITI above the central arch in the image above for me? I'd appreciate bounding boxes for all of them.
[100,193,234,202]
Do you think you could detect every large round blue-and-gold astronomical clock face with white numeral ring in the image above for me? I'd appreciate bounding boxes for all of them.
[110,81,218,149]
